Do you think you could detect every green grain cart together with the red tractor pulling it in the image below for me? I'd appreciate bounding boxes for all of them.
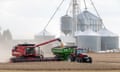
[52,46,92,63]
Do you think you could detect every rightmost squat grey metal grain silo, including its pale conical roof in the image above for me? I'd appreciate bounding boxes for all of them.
[98,28,119,51]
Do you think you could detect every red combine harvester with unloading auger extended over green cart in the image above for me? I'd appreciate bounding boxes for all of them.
[10,38,63,62]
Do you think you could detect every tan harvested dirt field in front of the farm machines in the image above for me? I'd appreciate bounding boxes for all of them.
[0,53,120,72]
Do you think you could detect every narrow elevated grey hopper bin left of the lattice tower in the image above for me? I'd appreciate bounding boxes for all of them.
[61,15,72,35]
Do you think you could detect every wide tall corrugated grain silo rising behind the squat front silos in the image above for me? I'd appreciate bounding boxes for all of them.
[77,10,102,32]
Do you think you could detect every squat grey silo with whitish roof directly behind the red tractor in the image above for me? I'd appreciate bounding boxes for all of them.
[76,29,101,52]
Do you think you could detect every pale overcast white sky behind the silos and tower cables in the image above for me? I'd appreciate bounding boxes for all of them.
[0,0,120,39]
